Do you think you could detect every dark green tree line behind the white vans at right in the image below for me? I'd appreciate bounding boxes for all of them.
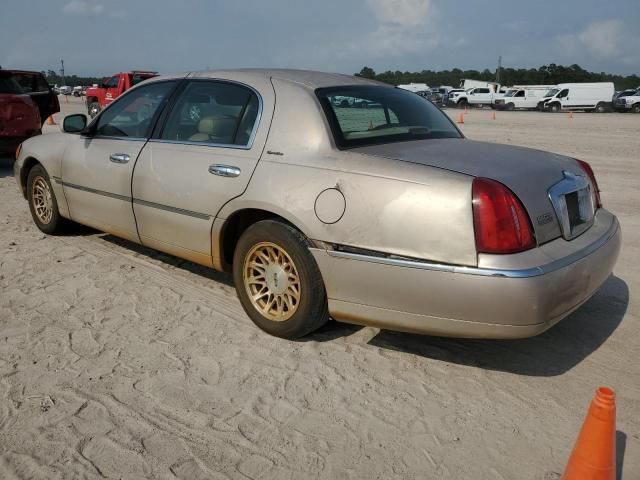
[355,63,640,90]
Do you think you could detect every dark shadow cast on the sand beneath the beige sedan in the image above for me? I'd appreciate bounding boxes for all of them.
[89,232,629,376]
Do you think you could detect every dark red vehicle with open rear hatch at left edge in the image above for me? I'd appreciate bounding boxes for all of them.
[0,70,60,154]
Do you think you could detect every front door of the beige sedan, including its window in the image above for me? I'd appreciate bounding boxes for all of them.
[62,81,177,242]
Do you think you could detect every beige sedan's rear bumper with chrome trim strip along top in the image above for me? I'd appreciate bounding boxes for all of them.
[312,210,621,338]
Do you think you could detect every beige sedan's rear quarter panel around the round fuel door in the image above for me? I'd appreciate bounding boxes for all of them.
[218,79,477,265]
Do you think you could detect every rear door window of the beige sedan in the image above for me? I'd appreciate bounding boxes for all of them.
[160,81,260,146]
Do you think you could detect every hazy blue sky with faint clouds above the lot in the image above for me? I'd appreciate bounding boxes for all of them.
[0,0,640,76]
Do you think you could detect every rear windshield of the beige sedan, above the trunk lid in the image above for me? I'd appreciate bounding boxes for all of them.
[316,85,462,148]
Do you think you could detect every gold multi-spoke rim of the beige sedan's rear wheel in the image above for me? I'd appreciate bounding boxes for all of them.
[243,242,301,322]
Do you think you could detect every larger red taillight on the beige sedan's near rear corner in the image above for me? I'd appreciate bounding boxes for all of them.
[472,177,536,253]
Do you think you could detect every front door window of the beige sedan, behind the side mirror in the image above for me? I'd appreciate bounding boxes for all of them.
[95,82,176,138]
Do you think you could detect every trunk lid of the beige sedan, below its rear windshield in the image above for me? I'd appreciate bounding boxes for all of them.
[352,139,589,244]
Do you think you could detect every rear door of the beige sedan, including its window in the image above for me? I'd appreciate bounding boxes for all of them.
[132,79,275,265]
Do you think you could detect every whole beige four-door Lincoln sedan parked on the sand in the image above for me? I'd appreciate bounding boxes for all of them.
[14,69,621,338]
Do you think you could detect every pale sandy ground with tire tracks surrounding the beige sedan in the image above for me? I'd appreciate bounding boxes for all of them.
[0,95,640,480]
